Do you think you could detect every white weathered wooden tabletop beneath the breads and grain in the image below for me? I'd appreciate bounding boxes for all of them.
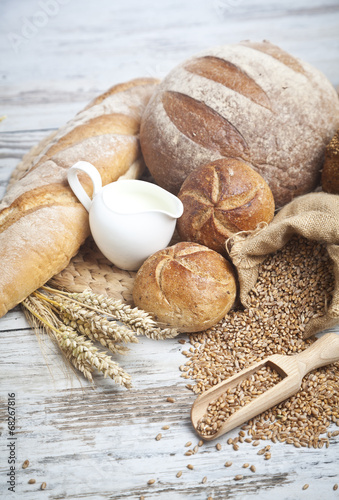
[0,0,339,500]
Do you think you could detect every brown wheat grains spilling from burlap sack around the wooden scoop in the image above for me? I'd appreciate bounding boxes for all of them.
[180,236,339,448]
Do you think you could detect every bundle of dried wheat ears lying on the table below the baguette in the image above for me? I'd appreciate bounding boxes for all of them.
[22,286,179,388]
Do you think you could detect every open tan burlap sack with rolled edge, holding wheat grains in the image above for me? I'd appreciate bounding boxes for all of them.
[226,192,339,338]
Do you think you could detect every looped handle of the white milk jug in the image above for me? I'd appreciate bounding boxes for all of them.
[67,161,102,212]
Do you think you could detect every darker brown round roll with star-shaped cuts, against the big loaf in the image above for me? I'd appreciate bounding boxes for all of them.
[177,159,274,255]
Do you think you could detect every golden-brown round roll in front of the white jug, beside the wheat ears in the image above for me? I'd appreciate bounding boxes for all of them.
[133,242,236,332]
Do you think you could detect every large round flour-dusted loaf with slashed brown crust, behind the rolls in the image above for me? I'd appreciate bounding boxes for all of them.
[140,41,339,207]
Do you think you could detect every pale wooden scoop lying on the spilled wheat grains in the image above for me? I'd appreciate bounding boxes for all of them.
[191,333,339,441]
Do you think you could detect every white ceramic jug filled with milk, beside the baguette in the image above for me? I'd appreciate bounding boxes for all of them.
[67,161,183,271]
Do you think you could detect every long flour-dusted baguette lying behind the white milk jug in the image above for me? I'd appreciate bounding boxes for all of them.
[0,78,157,317]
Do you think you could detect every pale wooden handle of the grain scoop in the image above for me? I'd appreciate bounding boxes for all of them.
[296,332,339,376]
